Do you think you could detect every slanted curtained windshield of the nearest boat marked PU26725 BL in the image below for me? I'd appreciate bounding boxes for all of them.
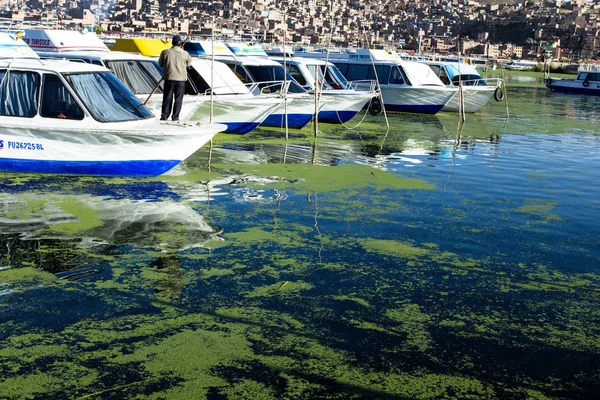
[65,72,153,122]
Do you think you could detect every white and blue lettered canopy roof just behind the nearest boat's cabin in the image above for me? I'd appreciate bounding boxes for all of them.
[23,29,110,52]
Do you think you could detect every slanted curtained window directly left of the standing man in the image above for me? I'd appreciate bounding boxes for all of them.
[106,60,163,94]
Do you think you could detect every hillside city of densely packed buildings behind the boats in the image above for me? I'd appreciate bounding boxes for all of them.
[0,0,600,62]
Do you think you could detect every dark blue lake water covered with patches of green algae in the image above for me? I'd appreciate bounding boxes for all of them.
[0,74,600,399]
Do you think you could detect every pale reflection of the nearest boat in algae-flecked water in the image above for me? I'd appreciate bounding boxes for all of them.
[0,193,222,278]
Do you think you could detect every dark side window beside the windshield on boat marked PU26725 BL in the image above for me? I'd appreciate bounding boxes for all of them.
[40,74,84,120]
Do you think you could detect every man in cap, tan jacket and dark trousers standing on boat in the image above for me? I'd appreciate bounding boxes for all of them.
[158,35,192,121]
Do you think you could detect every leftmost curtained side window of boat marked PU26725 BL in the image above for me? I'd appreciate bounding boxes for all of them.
[0,70,40,118]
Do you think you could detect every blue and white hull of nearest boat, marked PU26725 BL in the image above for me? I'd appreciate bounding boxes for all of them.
[0,117,225,176]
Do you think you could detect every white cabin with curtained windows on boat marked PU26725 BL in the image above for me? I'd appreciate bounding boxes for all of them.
[0,33,153,122]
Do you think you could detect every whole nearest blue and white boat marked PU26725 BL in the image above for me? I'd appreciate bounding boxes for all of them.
[0,33,226,176]
